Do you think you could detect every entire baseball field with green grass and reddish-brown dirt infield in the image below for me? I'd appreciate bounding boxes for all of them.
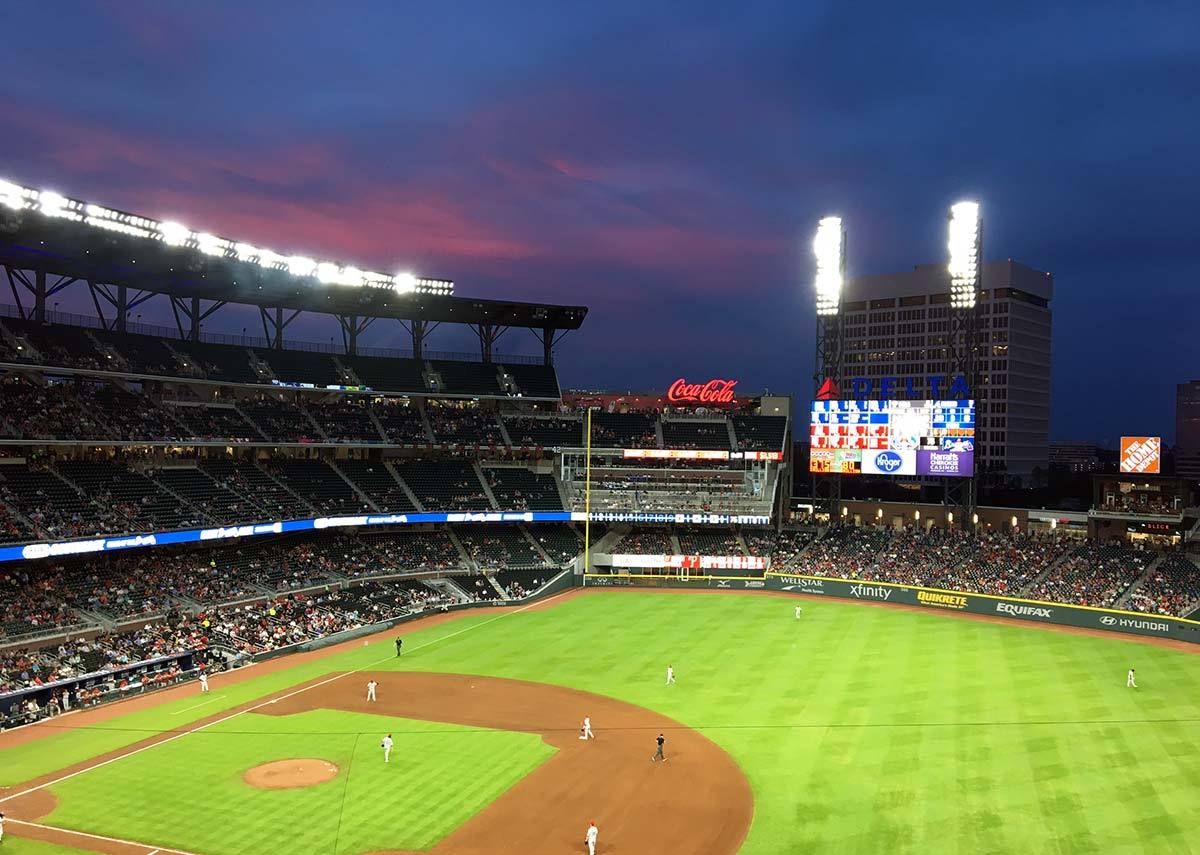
[0,591,1200,855]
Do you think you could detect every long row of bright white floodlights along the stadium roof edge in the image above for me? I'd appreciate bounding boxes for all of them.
[0,179,454,297]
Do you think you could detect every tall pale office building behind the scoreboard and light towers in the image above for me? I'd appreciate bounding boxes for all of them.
[836,261,1054,482]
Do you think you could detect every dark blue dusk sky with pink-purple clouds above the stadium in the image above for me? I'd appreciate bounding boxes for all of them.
[0,0,1200,443]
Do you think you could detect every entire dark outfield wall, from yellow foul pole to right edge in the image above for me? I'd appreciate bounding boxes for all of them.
[584,573,1200,644]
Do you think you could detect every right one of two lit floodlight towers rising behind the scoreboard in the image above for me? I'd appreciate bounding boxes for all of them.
[942,202,983,528]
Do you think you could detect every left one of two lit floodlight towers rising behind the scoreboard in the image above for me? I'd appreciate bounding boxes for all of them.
[812,216,846,521]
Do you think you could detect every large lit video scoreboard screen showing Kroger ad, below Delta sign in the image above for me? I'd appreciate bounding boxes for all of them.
[809,400,976,478]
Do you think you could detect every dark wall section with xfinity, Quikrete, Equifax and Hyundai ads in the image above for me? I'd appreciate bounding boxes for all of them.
[767,574,1200,644]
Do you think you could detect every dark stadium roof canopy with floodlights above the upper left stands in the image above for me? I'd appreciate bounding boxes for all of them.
[0,181,588,361]
